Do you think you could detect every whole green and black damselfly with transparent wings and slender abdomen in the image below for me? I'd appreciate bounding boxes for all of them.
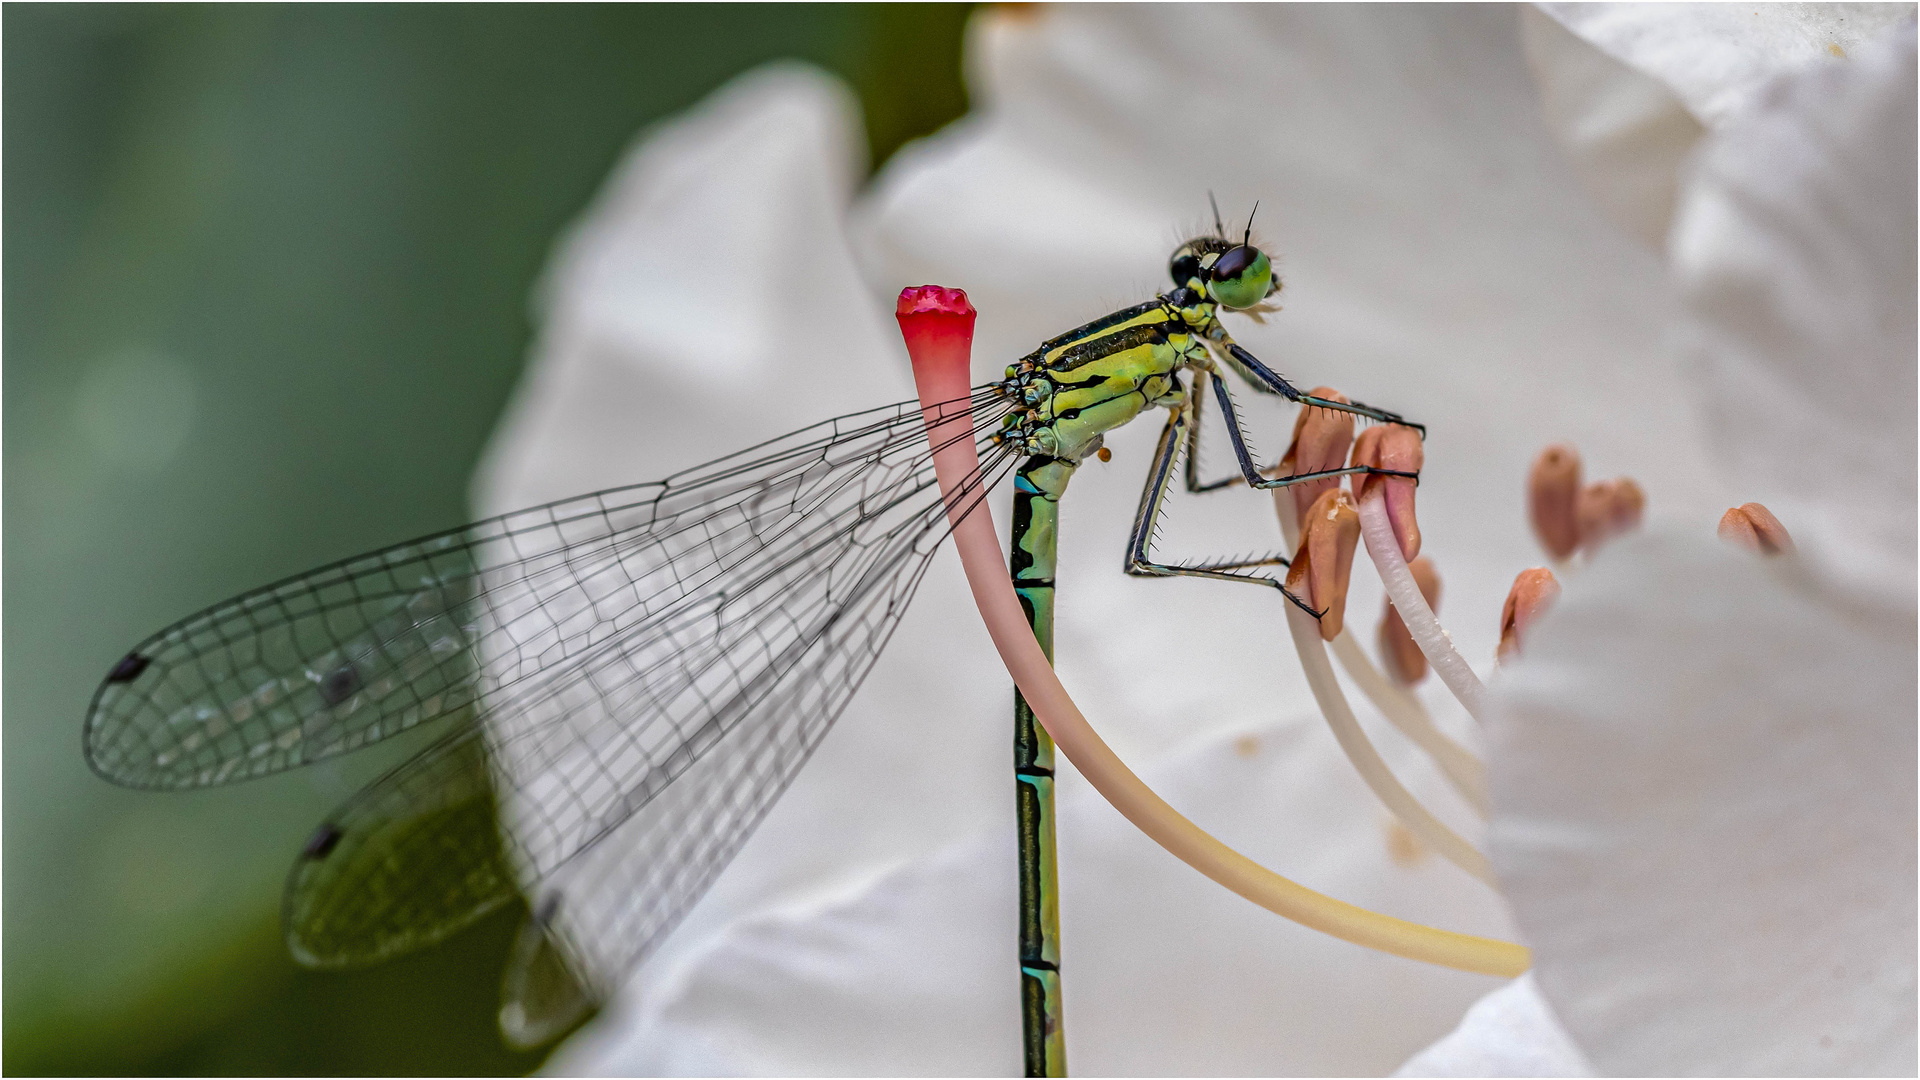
[84,219,1417,1072]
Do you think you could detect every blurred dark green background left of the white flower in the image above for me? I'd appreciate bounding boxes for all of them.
[0,4,966,1074]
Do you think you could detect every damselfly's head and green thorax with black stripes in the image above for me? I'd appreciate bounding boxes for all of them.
[995,236,1281,463]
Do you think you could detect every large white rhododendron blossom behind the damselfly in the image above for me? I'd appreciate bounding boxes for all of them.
[476,6,1916,1074]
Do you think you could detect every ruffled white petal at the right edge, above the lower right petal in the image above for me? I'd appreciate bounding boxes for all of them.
[1672,21,1916,613]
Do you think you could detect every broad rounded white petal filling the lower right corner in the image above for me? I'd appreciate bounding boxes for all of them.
[1490,530,1916,1076]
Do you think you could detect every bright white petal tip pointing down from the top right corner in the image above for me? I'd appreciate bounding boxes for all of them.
[1540,4,1912,127]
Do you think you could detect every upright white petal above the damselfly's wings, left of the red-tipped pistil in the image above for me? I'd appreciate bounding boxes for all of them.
[474,63,912,513]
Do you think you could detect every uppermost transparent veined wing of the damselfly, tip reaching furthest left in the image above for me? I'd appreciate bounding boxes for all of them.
[84,394,996,788]
